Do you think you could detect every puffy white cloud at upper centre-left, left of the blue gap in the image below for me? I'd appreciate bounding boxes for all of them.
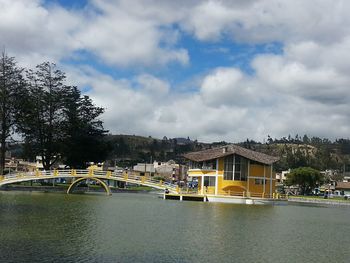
[77,5,188,66]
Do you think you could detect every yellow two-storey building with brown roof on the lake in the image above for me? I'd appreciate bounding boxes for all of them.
[185,144,278,202]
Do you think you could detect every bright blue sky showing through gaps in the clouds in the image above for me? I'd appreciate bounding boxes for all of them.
[59,21,283,87]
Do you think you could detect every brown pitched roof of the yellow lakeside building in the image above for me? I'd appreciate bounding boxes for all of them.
[184,144,279,164]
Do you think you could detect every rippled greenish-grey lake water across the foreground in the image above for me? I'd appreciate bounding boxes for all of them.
[0,192,350,263]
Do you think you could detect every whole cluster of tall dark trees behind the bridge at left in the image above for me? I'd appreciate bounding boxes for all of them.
[0,52,108,174]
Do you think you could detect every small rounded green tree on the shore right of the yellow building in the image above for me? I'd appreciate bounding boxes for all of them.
[286,167,323,194]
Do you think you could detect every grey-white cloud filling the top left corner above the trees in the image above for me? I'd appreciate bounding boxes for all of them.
[0,0,81,66]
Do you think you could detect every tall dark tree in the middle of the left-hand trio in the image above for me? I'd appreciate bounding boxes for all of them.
[18,62,74,170]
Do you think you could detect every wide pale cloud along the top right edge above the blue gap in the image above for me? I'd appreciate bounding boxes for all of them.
[180,0,350,43]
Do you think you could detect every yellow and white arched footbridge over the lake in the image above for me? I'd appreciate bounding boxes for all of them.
[0,169,179,195]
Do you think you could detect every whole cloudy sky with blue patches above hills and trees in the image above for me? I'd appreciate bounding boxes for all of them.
[0,0,350,142]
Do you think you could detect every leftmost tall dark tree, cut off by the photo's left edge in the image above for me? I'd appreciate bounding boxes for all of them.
[0,52,25,175]
